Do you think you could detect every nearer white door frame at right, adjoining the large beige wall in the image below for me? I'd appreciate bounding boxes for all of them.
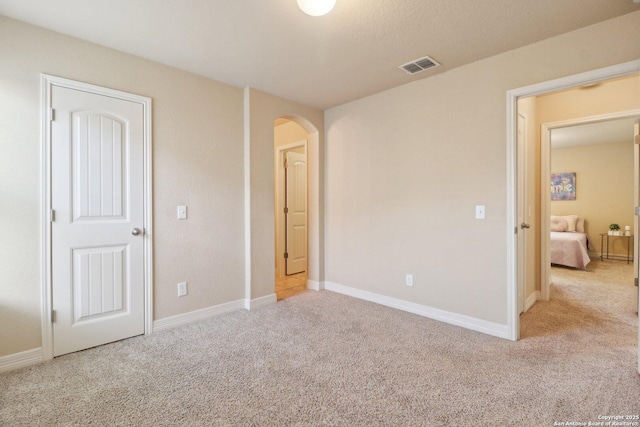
[506,60,640,341]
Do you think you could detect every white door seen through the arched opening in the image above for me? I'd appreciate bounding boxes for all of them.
[285,151,307,275]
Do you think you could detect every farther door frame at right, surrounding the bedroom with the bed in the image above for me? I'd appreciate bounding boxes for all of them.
[540,110,640,301]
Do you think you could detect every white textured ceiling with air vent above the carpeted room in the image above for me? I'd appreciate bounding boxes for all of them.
[0,0,640,109]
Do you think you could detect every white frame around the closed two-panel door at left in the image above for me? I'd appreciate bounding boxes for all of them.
[40,74,153,360]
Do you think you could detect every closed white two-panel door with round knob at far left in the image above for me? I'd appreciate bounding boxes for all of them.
[51,86,144,356]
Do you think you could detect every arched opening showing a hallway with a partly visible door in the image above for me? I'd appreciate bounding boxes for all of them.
[274,118,308,300]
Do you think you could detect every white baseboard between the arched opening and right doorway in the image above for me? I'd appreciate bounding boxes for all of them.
[324,282,509,339]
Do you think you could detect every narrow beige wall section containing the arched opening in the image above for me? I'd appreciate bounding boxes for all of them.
[246,89,324,299]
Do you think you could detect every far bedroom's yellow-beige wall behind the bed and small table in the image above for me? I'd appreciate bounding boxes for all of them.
[551,143,636,255]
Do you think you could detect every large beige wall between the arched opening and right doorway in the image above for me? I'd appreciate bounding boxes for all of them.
[325,12,640,325]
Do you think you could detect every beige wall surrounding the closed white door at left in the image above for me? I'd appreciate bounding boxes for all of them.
[0,17,245,356]
